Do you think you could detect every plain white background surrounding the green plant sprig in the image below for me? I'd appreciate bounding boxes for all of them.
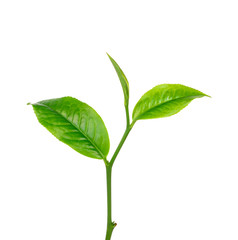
[0,0,238,240]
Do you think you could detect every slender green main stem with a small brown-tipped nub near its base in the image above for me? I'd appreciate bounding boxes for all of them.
[105,122,135,240]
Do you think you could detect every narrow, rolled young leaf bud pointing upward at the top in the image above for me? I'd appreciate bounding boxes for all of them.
[107,53,129,106]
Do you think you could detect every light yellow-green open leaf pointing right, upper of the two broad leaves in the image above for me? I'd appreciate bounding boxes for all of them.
[132,84,209,122]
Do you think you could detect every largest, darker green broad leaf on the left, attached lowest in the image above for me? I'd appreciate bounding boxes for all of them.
[32,97,110,160]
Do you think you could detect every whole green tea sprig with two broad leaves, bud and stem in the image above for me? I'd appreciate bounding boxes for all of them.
[28,54,209,240]
